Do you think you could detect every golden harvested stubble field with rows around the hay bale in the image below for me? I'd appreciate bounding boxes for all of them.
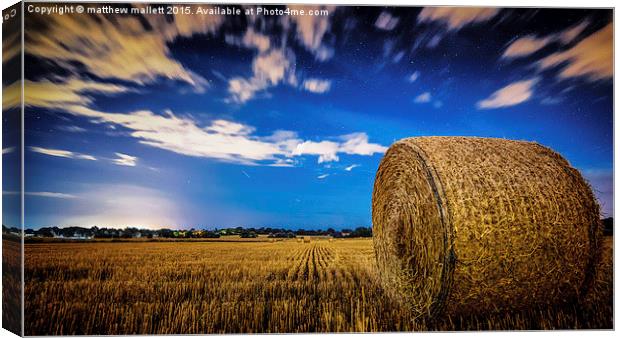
[25,238,612,335]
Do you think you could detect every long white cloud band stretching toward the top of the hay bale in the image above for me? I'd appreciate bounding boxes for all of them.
[41,106,387,166]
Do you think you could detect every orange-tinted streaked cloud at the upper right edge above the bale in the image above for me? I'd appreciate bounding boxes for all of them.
[538,23,614,81]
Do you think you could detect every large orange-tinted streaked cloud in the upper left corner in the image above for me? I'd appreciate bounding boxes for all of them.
[26,7,223,91]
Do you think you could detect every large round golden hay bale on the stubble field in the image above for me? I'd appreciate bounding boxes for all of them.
[372,137,601,318]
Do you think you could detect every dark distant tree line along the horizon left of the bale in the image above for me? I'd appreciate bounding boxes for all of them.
[2,225,372,239]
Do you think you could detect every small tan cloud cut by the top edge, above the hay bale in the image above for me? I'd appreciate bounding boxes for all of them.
[418,7,499,30]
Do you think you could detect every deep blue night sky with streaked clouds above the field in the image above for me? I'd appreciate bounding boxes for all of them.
[4,6,613,229]
